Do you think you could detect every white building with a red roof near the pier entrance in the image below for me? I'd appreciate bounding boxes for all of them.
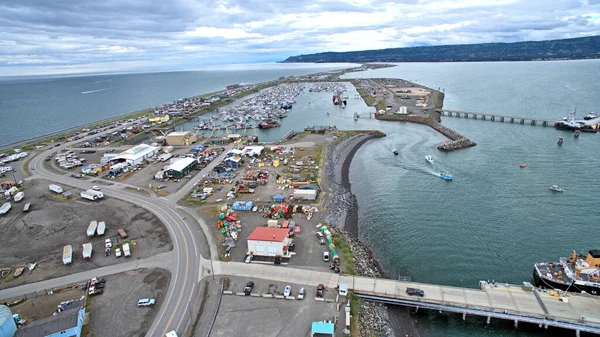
[247,227,292,257]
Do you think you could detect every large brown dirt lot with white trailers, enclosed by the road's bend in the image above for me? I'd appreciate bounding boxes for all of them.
[0,180,173,288]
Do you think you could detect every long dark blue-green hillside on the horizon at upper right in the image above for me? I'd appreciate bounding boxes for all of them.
[283,36,600,63]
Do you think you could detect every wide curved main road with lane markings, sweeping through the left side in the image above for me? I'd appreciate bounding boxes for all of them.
[29,146,201,337]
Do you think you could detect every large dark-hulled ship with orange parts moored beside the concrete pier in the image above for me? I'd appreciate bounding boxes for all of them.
[533,249,600,295]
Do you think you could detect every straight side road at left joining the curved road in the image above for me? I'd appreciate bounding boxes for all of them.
[0,251,173,300]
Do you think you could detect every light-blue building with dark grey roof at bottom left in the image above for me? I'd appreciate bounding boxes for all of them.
[15,299,85,337]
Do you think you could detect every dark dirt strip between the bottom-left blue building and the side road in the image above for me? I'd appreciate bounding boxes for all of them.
[10,286,85,322]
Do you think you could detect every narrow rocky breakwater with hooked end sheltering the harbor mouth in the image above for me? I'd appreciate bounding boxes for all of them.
[375,113,477,152]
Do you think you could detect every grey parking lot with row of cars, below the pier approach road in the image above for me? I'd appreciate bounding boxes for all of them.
[210,278,343,337]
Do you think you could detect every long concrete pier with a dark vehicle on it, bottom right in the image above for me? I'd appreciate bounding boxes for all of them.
[339,275,600,336]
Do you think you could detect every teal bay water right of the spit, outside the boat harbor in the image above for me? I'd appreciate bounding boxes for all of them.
[342,60,600,337]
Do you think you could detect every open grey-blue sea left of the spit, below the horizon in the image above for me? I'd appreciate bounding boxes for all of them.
[0,63,355,146]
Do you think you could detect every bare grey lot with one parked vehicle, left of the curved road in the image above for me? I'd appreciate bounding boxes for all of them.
[88,268,171,337]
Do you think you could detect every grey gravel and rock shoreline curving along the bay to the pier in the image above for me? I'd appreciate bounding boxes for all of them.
[323,134,419,337]
